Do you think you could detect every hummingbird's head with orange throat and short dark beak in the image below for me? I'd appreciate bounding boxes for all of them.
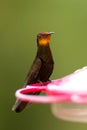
[37,32,54,46]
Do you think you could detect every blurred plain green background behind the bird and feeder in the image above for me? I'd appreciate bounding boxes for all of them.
[0,0,87,130]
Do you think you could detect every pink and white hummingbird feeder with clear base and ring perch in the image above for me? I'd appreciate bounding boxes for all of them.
[15,67,87,122]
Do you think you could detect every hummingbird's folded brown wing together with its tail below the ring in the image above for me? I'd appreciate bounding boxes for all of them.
[12,58,42,112]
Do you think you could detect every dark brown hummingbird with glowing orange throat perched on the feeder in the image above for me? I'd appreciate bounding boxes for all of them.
[12,32,54,113]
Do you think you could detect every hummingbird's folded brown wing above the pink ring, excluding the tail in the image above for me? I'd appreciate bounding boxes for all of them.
[25,58,42,85]
